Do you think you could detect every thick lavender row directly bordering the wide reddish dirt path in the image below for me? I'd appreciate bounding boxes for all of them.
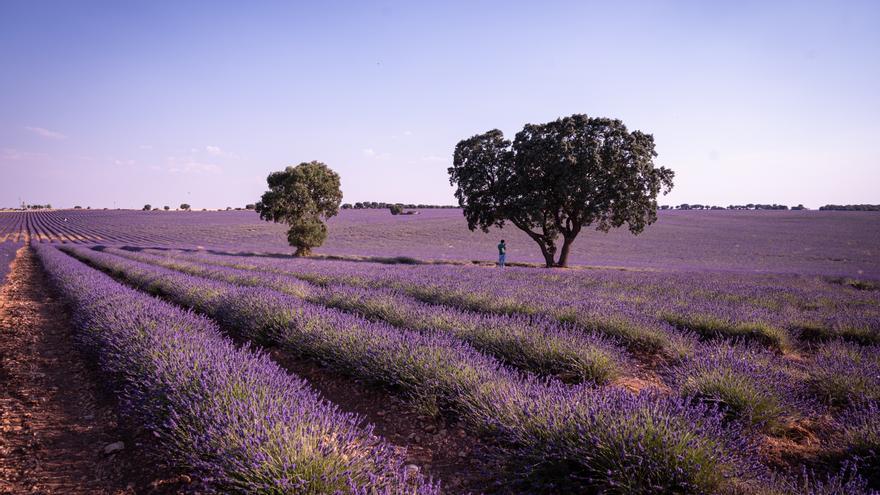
[36,246,438,494]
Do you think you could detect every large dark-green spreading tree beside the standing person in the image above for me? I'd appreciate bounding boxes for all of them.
[449,114,674,267]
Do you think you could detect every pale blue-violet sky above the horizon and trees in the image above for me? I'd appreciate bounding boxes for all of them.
[0,0,880,208]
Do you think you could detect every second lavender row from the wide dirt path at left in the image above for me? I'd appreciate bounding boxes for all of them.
[62,249,872,493]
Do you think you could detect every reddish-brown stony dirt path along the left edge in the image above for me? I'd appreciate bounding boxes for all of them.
[0,247,188,494]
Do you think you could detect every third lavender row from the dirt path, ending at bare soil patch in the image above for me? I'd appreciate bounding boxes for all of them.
[105,248,626,384]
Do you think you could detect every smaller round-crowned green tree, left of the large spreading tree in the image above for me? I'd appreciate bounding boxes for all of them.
[255,161,342,256]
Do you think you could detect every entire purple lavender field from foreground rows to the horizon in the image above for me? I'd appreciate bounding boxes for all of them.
[0,210,880,494]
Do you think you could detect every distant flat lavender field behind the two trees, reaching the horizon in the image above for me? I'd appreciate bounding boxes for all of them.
[0,209,880,279]
